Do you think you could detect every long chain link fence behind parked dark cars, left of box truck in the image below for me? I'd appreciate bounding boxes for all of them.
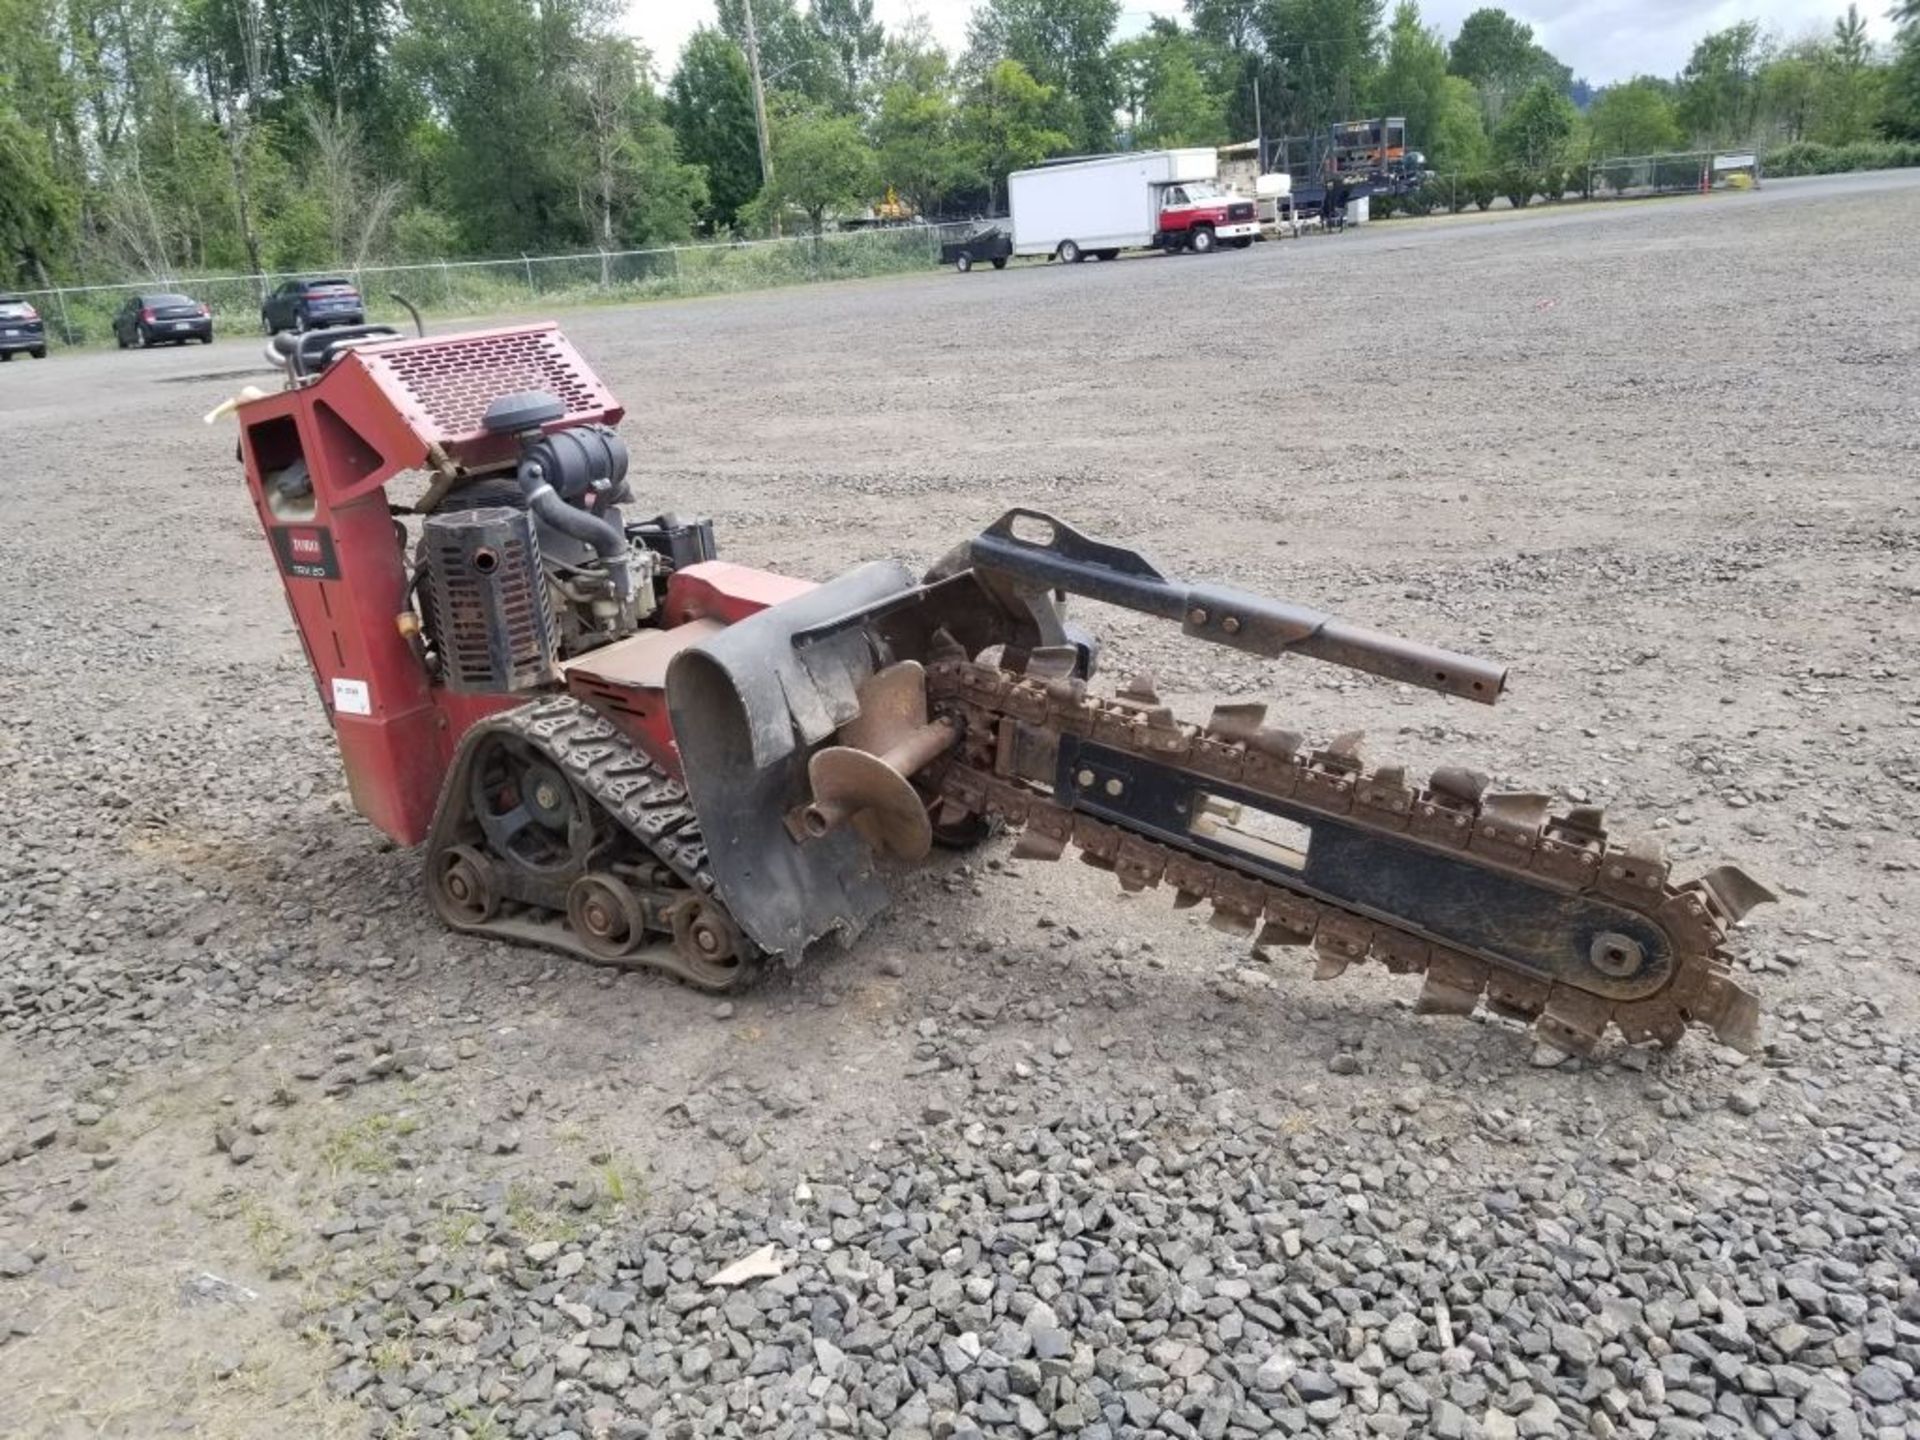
[19,223,973,346]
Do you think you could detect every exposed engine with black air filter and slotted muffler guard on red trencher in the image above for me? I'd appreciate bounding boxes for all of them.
[415,390,714,693]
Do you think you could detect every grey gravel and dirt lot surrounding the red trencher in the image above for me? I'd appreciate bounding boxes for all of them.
[0,177,1920,1440]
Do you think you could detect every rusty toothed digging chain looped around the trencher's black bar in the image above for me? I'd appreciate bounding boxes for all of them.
[927,659,1770,1054]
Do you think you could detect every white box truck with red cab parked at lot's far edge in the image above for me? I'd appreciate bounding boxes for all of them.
[1006,150,1260,263]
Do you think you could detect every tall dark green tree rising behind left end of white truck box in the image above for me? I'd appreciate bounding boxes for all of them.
[968,0,1119,152]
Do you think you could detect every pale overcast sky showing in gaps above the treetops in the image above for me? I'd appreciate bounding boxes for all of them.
[628,0,1893,84]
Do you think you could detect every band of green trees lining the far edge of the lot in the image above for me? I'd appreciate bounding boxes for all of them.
[0,0,1920,293]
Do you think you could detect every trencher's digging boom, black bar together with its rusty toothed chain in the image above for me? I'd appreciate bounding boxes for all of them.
[927,659,1774,1054]
